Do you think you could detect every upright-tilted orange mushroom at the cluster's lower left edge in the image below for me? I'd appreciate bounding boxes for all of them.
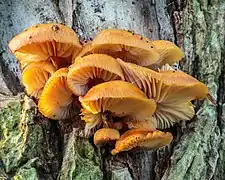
[38,68,74,120]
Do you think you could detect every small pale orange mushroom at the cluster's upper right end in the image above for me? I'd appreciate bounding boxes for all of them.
[152,40,184,66]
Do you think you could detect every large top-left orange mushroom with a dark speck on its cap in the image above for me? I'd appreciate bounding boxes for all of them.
[9,23,82,69]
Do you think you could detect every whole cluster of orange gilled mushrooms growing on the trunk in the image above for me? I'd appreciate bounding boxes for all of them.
[9,23,208,155]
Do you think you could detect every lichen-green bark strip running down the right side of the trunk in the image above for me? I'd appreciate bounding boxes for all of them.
[162,0,225,180]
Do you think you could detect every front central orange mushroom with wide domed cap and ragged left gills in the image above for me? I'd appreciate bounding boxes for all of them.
[79,80,156,132]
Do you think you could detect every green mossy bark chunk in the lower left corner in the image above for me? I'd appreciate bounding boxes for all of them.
[0,97,46,180]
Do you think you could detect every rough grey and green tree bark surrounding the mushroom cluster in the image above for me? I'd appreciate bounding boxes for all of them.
[0,0,225,180]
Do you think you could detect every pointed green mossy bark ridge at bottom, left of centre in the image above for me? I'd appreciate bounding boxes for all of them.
[58,133,103,180]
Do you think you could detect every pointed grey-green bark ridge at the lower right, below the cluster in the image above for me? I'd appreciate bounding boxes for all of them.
[167,102,220,180]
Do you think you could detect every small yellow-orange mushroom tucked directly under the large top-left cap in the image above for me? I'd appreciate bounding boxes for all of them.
[22,61,56,99]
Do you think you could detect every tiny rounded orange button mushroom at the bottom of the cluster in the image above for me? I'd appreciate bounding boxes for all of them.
[94,128,120,146]
